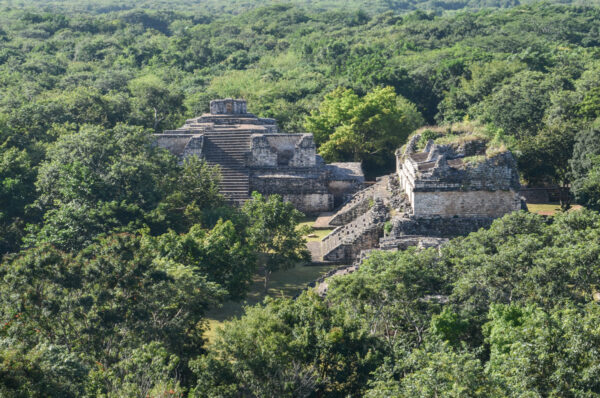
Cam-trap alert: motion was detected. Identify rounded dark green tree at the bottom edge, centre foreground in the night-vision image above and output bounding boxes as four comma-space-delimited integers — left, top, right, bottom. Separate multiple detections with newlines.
191, 292, 381, 397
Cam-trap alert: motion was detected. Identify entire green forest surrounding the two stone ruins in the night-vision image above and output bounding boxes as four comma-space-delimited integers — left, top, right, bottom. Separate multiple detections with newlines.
0, 0, 600, 397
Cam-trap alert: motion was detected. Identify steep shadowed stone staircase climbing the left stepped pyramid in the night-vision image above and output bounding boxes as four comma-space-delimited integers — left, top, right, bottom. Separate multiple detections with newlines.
203, 130, 253, 204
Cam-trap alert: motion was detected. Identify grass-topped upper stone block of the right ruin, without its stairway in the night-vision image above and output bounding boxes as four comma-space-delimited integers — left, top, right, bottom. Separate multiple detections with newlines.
397, 134, 521, 218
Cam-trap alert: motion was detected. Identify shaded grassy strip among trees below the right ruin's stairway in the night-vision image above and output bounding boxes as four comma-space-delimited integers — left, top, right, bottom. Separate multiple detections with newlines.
204, 265, 337, 340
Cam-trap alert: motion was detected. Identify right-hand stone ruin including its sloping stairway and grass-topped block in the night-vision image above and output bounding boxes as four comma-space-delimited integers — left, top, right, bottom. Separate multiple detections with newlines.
310, 128, 525, 264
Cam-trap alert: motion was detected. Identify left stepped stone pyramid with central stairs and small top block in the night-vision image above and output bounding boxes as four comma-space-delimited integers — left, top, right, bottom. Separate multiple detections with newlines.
156, 98, 364, 214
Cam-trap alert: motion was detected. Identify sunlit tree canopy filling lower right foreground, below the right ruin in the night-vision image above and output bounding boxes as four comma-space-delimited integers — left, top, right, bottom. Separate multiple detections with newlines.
195, 211, 600, 397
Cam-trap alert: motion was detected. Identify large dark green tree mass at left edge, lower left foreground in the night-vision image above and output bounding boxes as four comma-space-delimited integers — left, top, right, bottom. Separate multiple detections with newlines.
0, 234, 223, 372
